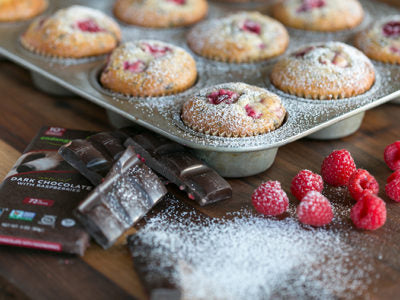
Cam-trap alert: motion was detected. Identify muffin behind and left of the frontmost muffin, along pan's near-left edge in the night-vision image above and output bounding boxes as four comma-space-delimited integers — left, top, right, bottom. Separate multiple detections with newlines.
100, 40, 197, 97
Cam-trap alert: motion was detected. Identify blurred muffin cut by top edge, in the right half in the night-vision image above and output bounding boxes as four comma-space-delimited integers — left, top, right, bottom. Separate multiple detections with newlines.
272, 0, 364, 31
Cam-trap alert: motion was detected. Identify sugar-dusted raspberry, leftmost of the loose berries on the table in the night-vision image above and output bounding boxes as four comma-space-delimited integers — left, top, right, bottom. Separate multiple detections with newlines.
251, 181, 289, 216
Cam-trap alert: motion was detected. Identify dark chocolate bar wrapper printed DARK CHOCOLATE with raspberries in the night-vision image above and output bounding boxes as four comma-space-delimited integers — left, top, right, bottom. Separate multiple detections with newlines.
0, 127, 93, 255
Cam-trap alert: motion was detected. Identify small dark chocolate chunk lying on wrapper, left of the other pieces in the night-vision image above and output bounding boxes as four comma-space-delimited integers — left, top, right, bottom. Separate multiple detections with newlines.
58, 139, 113, 185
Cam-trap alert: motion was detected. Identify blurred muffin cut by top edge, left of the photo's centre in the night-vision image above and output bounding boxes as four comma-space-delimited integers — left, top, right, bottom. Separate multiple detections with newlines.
114, 0, 208, 27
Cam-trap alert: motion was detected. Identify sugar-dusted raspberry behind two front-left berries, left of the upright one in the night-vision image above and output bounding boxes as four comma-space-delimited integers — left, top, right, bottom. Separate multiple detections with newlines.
290, 170, 324, 200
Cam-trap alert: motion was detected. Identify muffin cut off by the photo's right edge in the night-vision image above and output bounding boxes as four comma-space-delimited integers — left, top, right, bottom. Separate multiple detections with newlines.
355, 15, 400, 64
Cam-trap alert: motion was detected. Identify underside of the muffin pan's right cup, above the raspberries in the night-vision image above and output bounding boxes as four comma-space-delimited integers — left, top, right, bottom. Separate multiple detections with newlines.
308, 112, 365, 140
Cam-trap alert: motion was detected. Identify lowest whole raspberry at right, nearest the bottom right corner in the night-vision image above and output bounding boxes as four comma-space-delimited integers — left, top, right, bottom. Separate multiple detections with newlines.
350, 192, 386, 230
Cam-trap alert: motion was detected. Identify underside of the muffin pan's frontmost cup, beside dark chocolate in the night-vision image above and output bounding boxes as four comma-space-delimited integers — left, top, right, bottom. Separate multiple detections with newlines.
193, 148, 278, 178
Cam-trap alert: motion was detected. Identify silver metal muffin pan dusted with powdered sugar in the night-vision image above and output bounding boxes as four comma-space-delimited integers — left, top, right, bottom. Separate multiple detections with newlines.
0, 0, 400, 177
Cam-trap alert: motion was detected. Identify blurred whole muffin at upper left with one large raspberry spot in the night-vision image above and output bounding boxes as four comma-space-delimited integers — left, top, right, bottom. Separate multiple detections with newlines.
21, 5, 121, 58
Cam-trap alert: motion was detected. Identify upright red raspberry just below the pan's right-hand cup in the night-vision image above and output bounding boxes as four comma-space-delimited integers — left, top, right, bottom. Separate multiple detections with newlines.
321, 149, 356, 186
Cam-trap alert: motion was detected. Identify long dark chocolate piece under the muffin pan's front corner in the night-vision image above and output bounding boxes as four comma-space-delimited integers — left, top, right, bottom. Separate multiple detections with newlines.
124, 133, 232, 206
